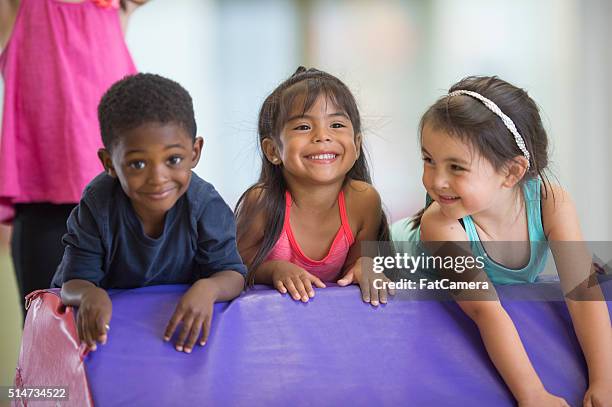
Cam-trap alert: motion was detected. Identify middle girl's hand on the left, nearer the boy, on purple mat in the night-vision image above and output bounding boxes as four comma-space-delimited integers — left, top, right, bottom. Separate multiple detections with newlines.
272, 262, 325, 302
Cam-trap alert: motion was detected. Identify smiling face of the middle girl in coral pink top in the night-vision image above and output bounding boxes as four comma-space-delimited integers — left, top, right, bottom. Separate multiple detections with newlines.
264, 95, 361, 184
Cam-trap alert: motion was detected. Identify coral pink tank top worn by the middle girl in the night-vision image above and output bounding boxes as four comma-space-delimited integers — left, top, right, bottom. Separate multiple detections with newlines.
266, 191, 355, 281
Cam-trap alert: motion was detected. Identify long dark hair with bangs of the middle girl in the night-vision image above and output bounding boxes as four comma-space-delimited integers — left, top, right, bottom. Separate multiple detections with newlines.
234, 66, 389, 285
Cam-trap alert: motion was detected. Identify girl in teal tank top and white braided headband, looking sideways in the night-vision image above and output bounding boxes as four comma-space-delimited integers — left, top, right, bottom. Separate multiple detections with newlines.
391, 77, 612, 406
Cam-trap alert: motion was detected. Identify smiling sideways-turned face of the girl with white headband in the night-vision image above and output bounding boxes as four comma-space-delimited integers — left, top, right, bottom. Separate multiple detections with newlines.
422, 125, 507, 219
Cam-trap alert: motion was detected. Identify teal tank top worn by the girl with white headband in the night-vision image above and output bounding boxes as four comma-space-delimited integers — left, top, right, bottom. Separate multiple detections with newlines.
391, 178, 549, 284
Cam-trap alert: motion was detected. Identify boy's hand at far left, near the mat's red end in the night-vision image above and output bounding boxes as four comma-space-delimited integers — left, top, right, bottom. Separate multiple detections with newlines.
77, 287, 113, 351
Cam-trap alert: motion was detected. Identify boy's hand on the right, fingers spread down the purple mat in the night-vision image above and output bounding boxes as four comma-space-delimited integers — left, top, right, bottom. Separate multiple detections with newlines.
164, 278, 215, 353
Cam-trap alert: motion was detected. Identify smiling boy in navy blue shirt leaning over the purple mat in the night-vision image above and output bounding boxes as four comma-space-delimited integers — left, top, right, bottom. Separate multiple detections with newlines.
53, 74, 246, 353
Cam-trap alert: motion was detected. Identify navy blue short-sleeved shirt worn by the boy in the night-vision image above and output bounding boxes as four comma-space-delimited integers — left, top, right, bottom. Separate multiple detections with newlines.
52, 173, 246, 289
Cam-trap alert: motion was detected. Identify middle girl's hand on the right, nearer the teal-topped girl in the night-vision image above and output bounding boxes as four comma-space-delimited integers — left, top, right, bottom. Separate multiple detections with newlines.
338, 257, 395, 307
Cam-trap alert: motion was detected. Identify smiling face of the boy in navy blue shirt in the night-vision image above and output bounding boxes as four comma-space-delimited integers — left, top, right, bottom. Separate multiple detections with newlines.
98, 123, 202, 224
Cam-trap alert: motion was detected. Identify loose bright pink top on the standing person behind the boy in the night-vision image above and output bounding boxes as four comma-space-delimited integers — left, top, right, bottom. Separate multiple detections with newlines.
0, 0, 136, 222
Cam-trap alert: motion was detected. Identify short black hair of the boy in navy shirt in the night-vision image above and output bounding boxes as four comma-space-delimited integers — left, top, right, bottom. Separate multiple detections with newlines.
98, 73, 197, 150
